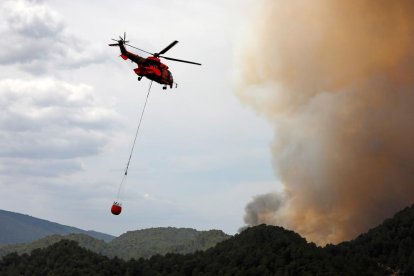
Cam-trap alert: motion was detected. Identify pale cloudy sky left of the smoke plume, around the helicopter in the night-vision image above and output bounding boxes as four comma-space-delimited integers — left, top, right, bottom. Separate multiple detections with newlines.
0, 0, 280, 235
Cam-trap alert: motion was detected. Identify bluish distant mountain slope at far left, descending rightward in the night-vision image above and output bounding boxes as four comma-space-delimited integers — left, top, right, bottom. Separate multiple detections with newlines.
0, 210, 114, 245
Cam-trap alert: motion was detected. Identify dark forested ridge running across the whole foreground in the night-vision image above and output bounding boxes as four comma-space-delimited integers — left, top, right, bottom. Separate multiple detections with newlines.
0, 206, 414, 276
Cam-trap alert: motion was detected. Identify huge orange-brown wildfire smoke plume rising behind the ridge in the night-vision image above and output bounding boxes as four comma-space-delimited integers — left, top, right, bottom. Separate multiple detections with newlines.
237, 0, 414, 244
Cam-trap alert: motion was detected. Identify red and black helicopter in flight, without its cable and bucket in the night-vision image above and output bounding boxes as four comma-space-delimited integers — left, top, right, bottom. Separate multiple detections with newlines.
109, 33, 201, 89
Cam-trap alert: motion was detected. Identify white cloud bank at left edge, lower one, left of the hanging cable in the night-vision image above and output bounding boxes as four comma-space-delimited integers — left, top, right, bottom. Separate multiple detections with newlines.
0, 78, 118, 175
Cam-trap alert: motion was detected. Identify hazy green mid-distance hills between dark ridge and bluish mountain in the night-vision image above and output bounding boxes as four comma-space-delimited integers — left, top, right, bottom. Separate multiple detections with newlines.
0, 227, 230, 260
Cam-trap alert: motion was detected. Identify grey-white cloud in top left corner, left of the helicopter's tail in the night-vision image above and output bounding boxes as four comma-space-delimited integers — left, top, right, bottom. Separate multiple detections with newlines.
0, 0, 105, 74
